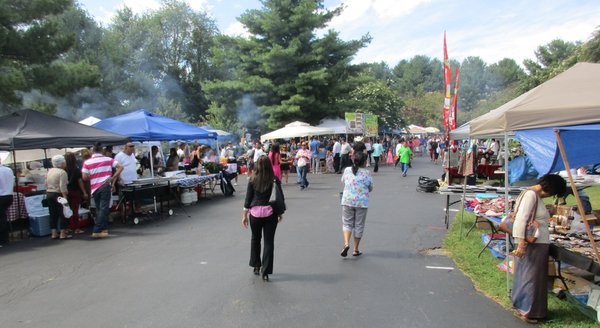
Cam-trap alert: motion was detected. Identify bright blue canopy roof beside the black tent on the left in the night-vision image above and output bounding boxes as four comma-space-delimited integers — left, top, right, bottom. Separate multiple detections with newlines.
93, 109, 217, 141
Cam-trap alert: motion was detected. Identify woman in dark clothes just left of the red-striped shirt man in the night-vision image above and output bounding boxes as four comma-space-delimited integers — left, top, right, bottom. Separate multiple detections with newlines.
65, 153, 88, 234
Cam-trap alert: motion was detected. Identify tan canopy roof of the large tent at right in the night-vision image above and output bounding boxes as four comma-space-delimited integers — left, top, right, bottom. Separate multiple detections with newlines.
470, 63, 600, 137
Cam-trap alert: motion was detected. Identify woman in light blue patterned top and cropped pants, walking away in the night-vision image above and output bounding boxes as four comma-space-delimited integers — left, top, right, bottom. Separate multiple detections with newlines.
340, 152, 373, 257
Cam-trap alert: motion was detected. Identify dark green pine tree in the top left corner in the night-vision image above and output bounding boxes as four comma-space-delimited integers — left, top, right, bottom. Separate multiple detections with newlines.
0, 0, 99, 112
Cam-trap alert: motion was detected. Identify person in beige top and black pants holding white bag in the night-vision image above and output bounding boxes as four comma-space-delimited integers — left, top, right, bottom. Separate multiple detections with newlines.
46, 155, 72, 240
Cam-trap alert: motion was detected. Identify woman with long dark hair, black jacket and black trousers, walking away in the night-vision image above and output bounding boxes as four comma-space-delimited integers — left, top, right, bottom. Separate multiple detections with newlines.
242, 156, 282, 281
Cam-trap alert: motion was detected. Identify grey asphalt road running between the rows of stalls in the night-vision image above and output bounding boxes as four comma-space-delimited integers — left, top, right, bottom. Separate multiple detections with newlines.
0, 157, 526, 328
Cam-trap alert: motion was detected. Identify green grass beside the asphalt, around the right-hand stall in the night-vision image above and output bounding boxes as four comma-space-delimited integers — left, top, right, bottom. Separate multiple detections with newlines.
444, 186, 600, 327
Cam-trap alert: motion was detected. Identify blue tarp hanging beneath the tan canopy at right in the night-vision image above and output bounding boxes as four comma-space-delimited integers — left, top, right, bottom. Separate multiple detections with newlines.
515, 124, 600, 176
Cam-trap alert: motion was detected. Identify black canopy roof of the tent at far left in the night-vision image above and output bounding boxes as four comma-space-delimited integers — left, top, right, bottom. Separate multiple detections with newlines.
0, 109, 128, 150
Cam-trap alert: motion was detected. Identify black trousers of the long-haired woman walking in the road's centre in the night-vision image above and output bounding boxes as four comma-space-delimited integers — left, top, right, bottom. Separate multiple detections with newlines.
250, 215, 277, 274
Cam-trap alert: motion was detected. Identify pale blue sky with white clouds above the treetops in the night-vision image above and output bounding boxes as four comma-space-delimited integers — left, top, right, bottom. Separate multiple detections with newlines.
77, 0, 600, 67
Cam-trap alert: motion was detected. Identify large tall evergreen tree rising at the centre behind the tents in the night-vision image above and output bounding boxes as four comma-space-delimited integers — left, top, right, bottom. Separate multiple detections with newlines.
207, 0, 370, 128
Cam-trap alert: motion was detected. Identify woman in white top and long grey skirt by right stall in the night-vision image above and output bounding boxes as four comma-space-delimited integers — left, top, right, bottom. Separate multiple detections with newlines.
512, 174, 566, 323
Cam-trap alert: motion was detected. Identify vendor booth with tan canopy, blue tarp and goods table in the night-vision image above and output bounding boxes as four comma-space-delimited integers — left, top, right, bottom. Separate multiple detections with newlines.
444, 63, 600, 320
